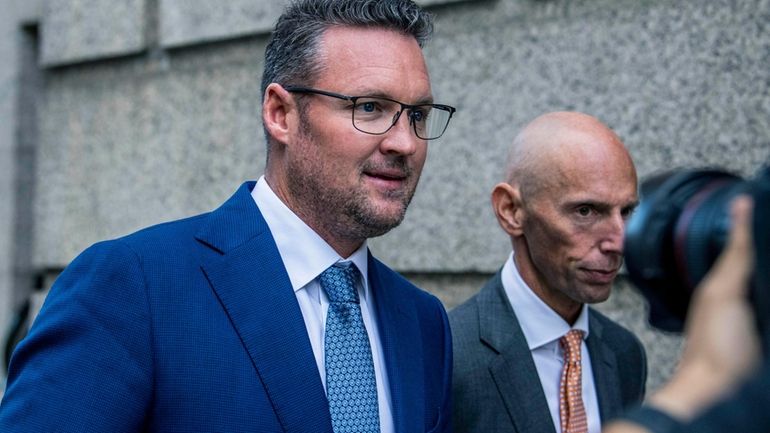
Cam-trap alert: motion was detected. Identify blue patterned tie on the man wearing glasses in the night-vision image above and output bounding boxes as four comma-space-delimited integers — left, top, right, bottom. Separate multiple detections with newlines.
320, 262, 380, 433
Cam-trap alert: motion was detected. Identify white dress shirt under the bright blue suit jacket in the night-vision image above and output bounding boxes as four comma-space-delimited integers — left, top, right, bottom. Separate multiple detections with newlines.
251, 176, 395, 433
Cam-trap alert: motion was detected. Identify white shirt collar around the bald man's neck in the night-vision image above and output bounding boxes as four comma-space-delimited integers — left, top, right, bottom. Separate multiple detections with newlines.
501, 253, 588, 350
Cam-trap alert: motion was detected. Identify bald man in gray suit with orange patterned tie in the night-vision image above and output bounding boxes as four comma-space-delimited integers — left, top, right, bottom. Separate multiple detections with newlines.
449, 112, 647, 433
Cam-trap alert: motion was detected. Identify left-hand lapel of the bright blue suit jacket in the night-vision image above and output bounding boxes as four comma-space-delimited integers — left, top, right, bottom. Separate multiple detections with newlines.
196, 183, 331, 432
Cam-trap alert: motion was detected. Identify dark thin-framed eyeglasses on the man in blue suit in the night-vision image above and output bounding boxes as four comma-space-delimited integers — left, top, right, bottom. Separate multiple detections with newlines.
284, 86, 457, 140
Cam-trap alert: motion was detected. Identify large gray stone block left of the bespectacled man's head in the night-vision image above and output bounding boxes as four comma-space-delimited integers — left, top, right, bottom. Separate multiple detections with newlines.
35, 39, 264, 267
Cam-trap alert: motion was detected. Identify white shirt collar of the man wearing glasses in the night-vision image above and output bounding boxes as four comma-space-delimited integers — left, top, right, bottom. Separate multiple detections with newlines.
251, 176, 369, 297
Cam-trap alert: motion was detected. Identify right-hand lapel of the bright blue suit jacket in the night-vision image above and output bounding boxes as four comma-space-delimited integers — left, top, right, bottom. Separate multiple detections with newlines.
369, 253, 425, 432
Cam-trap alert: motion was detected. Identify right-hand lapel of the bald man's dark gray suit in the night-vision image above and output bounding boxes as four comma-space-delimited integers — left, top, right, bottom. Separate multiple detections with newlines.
586, 309, 622, 420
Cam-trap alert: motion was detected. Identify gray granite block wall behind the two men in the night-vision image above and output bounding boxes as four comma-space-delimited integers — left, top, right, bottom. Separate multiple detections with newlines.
0, 0, 770, 394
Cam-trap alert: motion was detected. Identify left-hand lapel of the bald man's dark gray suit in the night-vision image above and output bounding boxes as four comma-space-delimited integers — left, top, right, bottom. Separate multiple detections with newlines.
477, 272, 556, 433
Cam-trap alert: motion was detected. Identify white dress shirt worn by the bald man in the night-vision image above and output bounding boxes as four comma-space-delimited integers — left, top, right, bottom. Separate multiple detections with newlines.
501, 253, 601, 433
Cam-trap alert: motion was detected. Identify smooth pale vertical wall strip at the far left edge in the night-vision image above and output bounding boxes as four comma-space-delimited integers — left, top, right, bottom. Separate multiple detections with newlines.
0, 0, 42, 386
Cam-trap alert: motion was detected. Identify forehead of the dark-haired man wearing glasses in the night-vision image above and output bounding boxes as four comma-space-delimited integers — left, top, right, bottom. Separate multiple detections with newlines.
314, 26, 431, 102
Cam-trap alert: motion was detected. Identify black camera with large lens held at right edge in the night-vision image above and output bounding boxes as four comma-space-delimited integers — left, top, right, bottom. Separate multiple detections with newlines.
624, 166, 770, 348
